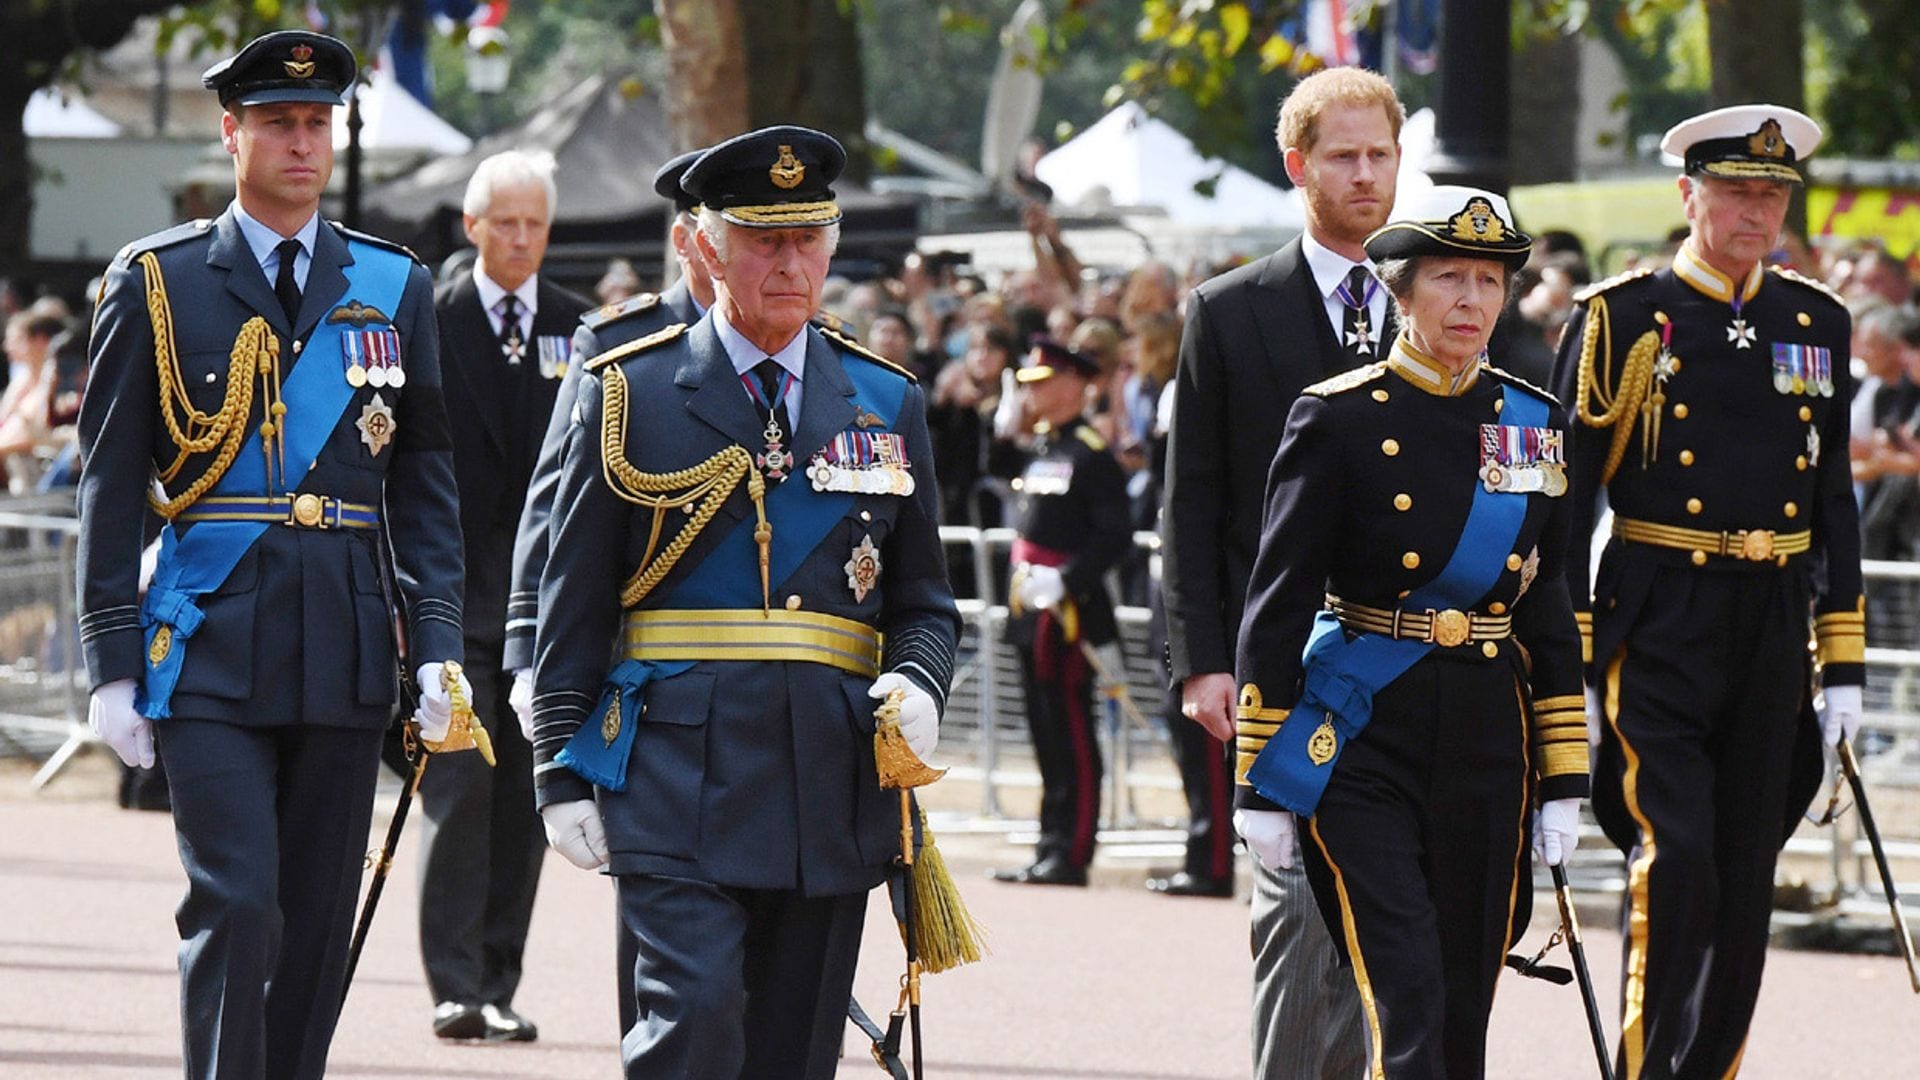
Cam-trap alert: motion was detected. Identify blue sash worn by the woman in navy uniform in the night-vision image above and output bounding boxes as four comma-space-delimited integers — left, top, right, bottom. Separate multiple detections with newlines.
1246, 386, 1548, 815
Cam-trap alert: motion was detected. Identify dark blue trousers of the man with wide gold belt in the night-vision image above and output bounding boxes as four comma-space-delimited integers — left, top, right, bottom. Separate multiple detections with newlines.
616, 874, 866, 1080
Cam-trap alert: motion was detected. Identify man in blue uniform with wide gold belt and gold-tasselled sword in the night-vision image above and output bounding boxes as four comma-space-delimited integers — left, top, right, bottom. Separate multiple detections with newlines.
534, 127, 958, 1080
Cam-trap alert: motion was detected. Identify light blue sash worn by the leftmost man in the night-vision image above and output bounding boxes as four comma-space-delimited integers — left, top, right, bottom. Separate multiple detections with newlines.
134, 240, 413, 721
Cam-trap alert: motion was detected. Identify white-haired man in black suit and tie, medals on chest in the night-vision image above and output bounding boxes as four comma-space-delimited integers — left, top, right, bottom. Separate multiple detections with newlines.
420, 150, 588, 1042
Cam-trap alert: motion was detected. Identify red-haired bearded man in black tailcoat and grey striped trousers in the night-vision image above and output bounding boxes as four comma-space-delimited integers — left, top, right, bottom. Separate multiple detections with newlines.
1160, 67, 1405, 1078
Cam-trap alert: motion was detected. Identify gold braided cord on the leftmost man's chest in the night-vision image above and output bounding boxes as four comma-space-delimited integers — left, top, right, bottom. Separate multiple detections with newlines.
140, 252, 286, 521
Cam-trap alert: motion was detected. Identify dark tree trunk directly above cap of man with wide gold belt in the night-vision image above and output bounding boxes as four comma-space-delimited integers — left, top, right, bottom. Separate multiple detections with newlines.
745, 0, 870, 181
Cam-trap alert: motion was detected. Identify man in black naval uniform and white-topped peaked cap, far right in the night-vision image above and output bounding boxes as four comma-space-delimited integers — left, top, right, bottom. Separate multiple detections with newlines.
1555, 106, 1866, 1080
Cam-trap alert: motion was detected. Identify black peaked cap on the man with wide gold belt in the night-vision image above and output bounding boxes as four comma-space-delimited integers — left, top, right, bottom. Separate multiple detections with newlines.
680, 125, 847, 229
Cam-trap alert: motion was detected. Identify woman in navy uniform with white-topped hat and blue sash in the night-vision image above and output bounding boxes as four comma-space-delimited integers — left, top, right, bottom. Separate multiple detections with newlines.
1238, 186, 1586, 1080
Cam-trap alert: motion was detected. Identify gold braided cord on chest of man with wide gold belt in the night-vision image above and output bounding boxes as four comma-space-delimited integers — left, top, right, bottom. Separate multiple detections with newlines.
601, 363, 774, 609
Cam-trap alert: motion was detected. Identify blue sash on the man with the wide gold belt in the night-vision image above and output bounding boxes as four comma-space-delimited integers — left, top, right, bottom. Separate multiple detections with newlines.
555, 353, 906, 780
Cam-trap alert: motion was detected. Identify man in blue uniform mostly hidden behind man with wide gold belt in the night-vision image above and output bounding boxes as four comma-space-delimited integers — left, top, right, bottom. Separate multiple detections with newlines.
503, 150, 714, 1032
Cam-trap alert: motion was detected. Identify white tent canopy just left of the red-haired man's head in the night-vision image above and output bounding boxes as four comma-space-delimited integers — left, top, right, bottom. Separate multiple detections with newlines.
1033, 102, 1306, 229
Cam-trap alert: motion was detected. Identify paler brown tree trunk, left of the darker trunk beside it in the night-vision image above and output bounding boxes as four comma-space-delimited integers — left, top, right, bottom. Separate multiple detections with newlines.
655, 0, 755, 150
